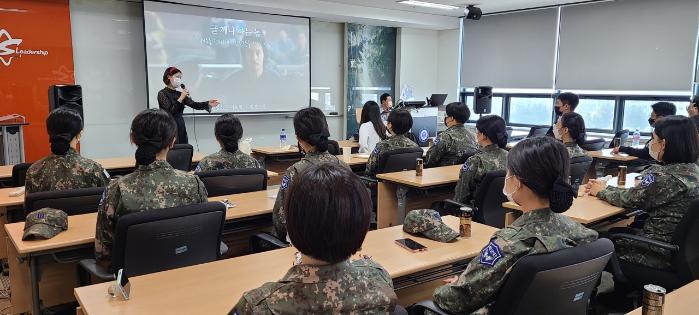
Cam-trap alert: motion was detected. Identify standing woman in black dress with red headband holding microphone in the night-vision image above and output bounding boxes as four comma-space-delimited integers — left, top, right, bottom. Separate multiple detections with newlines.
158, 67, 219, 143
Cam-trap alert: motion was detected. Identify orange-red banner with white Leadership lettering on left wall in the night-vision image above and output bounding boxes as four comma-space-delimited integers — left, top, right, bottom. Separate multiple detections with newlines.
0, 0, 75, 161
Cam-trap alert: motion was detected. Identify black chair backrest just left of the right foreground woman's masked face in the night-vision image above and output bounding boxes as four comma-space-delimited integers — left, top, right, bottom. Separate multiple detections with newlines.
473, 170, 507, 228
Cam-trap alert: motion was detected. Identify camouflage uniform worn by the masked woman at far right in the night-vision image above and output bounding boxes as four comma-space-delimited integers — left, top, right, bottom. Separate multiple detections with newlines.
597, 163, 699, 268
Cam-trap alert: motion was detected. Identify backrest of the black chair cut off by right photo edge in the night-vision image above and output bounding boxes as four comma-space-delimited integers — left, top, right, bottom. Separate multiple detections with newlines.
671, 199, 699, 283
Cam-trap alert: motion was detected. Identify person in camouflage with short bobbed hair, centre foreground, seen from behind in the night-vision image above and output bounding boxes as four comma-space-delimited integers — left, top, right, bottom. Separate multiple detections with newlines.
231, 162, 397, 314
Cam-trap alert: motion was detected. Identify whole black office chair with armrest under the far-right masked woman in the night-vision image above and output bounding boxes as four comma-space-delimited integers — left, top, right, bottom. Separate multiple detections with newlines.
611, 199, 699, 292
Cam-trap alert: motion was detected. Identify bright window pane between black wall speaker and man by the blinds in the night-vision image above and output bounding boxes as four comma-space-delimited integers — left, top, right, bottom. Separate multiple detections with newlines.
509, 97, 553, 126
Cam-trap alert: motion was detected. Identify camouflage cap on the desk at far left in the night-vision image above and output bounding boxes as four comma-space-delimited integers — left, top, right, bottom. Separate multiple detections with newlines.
22, 208, 68, 241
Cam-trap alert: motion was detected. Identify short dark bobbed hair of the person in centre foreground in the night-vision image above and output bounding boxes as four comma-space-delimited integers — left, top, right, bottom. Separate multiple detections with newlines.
284, 163, 372, 264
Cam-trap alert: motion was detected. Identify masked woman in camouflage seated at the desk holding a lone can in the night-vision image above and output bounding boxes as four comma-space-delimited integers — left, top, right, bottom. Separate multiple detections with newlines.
454, 115, 507, 204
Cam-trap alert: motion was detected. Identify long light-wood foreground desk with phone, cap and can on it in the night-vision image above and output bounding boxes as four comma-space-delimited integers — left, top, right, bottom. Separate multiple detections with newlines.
75, 217, 496, 315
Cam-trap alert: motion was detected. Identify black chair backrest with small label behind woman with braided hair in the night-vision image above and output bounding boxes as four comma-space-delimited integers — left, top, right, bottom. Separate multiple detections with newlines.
110, 202, 226, 277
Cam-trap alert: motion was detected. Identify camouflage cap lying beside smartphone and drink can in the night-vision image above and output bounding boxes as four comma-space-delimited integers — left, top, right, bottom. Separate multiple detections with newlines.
403, 209, 459, 243
